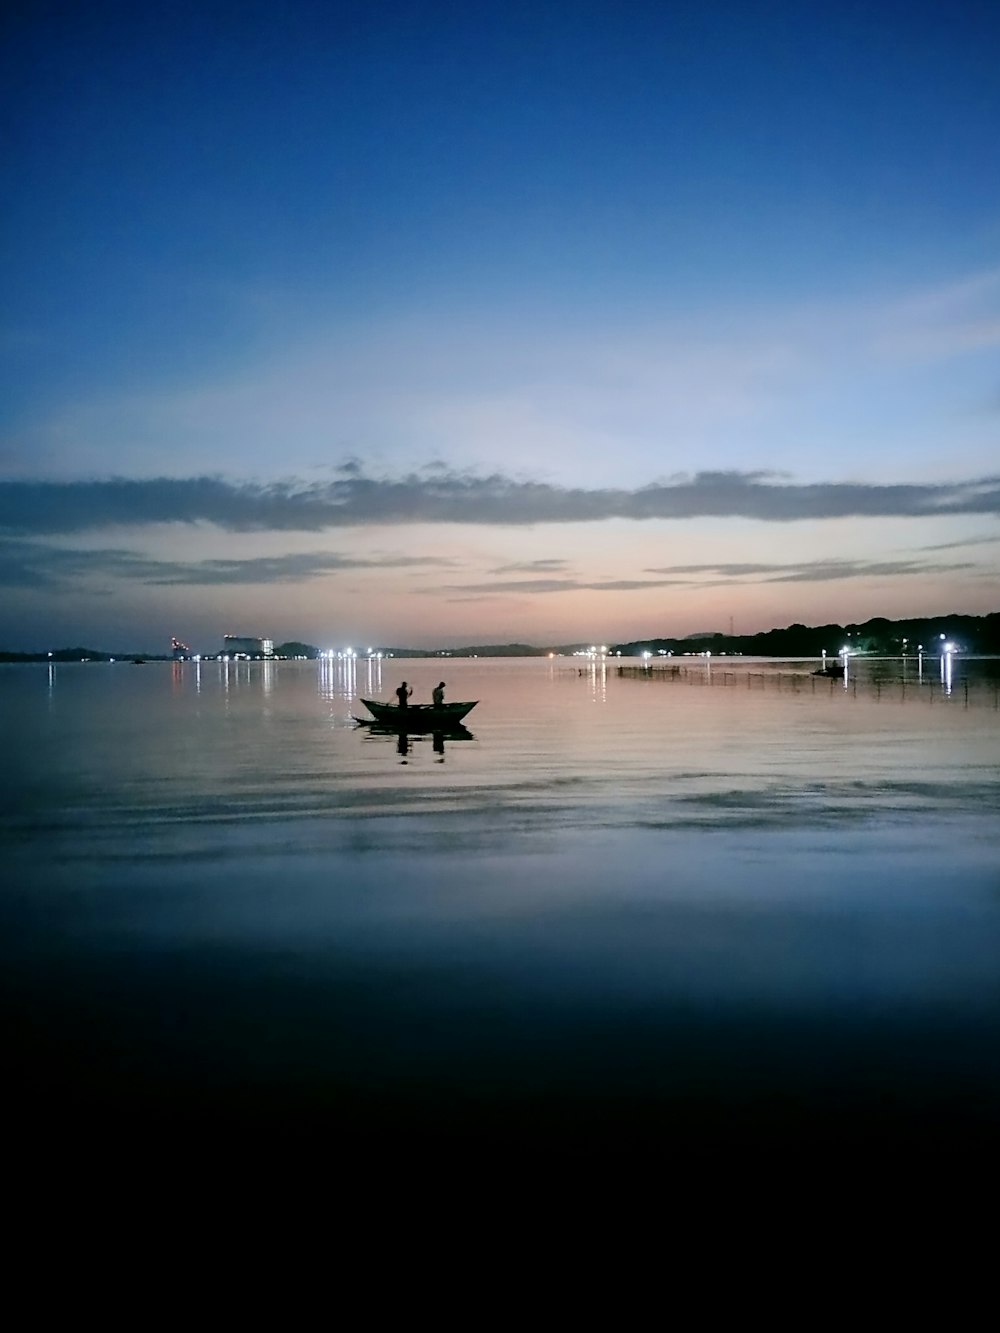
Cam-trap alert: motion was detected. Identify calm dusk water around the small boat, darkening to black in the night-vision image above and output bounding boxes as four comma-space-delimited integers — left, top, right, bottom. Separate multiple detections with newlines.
0, 659, 1000, 1156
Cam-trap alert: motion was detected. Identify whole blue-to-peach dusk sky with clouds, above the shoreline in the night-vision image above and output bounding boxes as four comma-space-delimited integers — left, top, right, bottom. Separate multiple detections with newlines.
0, 0, 1000, 652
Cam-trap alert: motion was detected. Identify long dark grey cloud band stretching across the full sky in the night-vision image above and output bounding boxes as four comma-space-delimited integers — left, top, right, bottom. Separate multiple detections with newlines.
0, 465, 1000, 535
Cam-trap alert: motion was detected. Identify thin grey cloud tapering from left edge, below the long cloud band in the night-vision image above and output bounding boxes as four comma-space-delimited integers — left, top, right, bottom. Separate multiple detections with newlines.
0, 539, 455, 588
